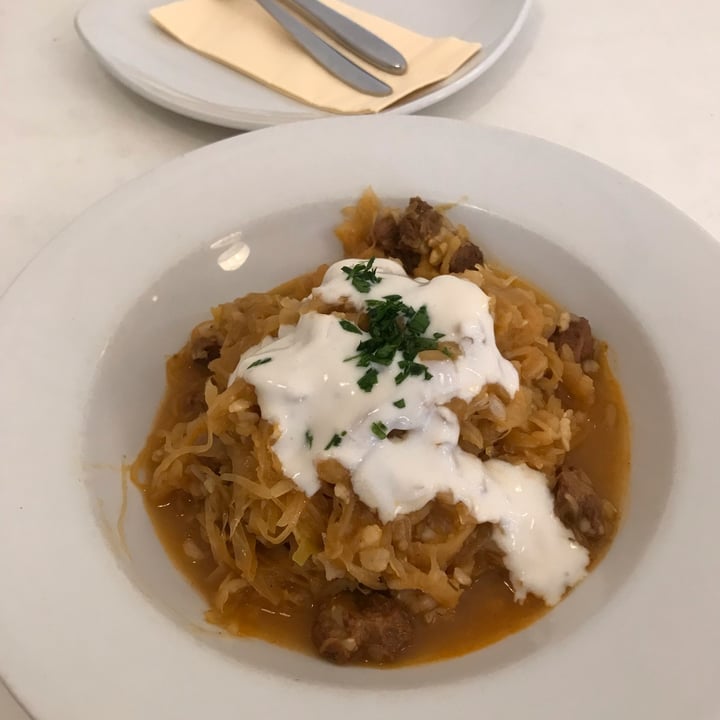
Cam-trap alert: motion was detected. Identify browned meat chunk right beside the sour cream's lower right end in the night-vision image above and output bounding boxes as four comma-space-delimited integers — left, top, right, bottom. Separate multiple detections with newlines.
555, 465, 612, 542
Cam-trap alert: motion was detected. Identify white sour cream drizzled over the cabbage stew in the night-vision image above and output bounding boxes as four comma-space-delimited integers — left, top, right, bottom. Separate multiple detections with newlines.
229, 259, 589, 605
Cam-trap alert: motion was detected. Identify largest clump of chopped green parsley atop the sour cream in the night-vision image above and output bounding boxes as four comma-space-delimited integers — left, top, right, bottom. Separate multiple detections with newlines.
347, 296, 443, 392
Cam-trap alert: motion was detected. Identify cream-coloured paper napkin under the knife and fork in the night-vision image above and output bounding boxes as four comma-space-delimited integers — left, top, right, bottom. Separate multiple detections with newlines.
150, 0, 480, 113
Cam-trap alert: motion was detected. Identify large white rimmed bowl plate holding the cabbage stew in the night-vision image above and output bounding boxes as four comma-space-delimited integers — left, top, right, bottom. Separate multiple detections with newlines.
0, 116, 720, 720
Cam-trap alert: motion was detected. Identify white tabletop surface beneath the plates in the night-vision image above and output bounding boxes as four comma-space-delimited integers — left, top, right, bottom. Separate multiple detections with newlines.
0, 0, 720, 720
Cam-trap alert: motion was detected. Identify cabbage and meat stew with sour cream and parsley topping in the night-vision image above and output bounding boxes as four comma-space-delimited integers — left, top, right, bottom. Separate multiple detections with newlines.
132, 191, 630, 665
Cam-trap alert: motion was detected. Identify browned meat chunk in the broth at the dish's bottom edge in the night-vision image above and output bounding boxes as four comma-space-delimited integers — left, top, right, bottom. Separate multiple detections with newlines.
312, 592, 413, 665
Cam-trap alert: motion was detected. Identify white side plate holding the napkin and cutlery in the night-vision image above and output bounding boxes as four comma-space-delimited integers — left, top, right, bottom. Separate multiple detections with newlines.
76, 0, 530, 130
